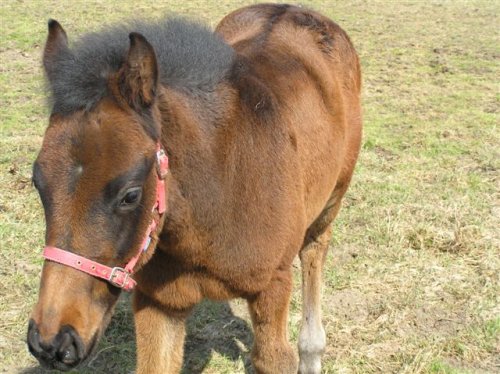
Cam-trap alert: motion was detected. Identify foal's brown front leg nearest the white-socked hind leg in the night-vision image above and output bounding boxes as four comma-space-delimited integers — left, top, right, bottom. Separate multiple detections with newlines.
248, 269, 297, 374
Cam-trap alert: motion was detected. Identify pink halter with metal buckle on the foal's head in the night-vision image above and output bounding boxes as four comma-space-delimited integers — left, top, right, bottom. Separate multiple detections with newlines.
43, 142, 168, 291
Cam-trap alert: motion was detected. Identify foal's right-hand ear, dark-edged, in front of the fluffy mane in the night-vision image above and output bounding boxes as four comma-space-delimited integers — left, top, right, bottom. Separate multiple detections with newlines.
120, 32, 158, 112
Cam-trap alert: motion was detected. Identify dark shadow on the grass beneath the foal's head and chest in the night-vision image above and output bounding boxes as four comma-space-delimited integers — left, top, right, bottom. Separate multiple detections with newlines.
18, 295, 254, 374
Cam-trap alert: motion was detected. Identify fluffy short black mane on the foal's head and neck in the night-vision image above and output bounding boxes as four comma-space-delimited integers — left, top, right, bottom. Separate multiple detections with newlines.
49, 18, 234, 114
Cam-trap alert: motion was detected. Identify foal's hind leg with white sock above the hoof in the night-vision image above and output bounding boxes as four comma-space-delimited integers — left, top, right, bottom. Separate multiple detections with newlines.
298, 198, 340, 374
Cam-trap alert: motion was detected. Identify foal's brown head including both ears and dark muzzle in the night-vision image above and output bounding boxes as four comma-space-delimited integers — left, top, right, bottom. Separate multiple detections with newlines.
28, 20, 165, 370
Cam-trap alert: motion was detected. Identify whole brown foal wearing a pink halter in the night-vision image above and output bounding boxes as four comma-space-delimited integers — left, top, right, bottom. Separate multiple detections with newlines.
28, 4, 361, 374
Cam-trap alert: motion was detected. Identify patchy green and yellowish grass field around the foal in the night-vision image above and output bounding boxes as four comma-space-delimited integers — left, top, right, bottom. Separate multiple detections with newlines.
0, 0, 500, 374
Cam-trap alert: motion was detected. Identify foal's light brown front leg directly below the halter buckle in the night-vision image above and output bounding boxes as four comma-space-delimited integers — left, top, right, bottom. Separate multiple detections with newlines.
134, 291, 188, 374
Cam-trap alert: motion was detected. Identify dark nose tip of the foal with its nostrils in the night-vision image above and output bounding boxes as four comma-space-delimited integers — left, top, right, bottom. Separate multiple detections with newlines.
27, 320, 88, 370
